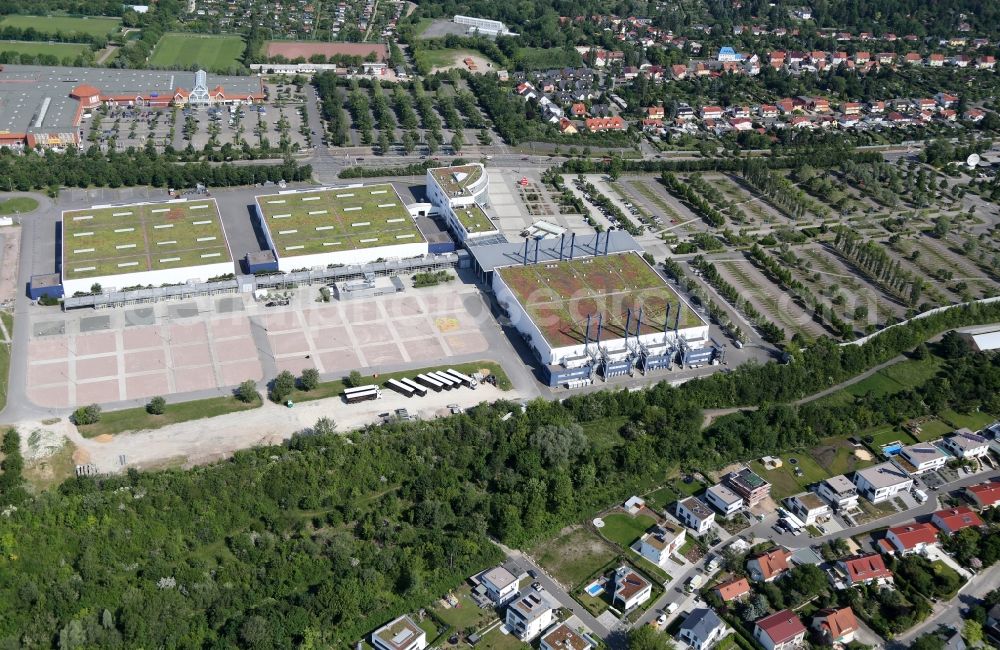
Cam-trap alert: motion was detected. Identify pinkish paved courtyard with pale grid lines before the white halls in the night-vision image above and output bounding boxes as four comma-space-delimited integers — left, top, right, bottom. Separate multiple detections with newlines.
23, 282, 491, 408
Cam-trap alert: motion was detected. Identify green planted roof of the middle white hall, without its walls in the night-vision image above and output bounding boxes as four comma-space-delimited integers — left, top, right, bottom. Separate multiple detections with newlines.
257, 183, 427, 258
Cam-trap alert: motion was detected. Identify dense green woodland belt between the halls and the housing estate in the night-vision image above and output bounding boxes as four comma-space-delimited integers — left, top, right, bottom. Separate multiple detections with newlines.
0, 298, 1000, 648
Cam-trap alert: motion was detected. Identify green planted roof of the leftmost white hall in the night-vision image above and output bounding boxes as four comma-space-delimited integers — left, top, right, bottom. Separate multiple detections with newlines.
62, 199, 232, 280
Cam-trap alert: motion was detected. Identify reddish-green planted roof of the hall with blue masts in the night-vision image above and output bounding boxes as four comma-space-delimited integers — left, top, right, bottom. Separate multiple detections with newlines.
496, 252, 705, 348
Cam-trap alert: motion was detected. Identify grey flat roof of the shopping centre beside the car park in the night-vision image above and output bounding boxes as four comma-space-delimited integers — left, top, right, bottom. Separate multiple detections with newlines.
0, 64, 261, 133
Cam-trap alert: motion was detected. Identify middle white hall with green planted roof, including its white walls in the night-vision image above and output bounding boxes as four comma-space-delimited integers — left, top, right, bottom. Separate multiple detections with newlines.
255, 183, 428, 272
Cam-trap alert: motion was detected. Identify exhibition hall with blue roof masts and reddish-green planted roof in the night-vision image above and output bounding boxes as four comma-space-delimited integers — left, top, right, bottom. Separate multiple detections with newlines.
491, 242, 716, 385
